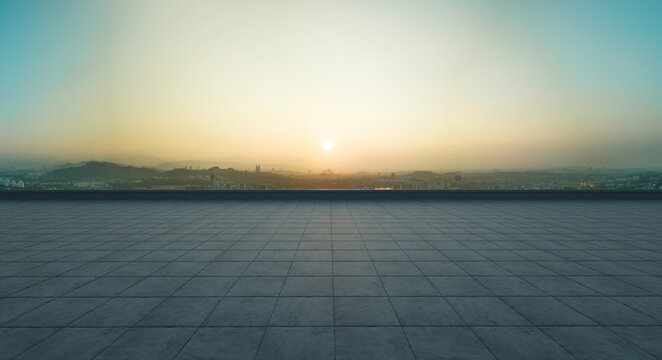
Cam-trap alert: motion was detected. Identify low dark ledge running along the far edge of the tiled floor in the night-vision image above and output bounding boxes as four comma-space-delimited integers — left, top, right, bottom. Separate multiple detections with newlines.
0, 190, 662, 201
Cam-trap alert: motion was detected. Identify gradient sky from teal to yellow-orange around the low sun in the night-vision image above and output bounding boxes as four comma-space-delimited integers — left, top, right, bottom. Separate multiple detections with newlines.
0, 0, 662, 171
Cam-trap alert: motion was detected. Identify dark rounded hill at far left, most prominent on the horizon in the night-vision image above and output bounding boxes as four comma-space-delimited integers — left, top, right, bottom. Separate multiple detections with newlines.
43, 161, 161, 179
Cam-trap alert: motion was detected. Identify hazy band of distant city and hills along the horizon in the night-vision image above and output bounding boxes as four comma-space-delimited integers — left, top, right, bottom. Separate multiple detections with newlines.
0, 161, 662, 190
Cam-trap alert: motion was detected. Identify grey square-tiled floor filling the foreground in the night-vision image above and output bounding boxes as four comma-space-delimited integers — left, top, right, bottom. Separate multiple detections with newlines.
0, 201, 662, 360
